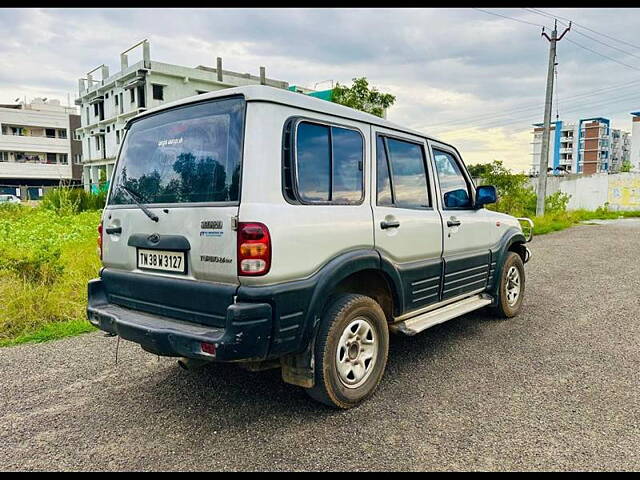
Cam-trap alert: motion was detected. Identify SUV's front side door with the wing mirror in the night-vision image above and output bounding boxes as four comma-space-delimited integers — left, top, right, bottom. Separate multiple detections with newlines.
430, 142, 496, 300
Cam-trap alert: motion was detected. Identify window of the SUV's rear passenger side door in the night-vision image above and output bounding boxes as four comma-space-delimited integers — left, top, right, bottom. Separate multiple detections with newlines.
376, 136, 431, 208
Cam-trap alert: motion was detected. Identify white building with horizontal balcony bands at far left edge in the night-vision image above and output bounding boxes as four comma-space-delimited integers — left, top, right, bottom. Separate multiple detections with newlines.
0, 98, 81, 199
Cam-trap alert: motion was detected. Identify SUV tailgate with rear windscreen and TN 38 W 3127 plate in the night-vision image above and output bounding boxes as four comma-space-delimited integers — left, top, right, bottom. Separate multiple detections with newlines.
103, 97, 245, 324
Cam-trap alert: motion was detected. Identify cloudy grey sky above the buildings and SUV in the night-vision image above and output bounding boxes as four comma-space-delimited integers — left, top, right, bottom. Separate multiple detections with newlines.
0, 8, 640, 171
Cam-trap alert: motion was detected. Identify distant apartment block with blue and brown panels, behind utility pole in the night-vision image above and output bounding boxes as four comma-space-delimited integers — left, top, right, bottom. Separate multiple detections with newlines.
530, 117, 631, 175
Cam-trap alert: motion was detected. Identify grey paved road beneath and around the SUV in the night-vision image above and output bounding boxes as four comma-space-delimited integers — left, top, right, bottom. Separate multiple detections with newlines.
0, 221, 640, 470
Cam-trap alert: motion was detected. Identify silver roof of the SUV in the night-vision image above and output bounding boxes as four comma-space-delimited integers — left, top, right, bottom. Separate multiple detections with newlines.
129, 85, 449, 145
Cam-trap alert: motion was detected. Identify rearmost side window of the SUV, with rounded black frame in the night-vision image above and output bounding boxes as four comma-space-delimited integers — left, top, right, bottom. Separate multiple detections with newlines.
284, 121, 364, 205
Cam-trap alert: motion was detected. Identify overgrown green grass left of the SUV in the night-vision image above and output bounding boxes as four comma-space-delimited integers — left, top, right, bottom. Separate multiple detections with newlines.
0, 206, 100, 346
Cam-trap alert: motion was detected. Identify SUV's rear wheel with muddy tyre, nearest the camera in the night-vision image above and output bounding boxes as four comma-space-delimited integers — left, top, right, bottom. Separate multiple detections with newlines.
306, 294, 389, 409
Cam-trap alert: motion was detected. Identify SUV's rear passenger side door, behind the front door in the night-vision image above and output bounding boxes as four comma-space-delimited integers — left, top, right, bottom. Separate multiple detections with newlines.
372, 128, 442, 313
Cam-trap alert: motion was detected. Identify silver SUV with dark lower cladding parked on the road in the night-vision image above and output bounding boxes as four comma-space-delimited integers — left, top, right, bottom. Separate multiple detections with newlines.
87, 86, 531, 408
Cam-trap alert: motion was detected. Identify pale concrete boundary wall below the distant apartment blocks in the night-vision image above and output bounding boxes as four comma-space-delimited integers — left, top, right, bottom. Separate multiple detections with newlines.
530, 173, 640, 210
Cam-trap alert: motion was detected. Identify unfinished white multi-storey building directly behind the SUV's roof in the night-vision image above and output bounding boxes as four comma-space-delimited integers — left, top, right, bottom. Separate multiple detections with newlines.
75, 40, 289, 189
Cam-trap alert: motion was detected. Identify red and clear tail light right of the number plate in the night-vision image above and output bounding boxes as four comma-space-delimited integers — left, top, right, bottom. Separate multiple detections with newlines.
238, 222, 271, 276
